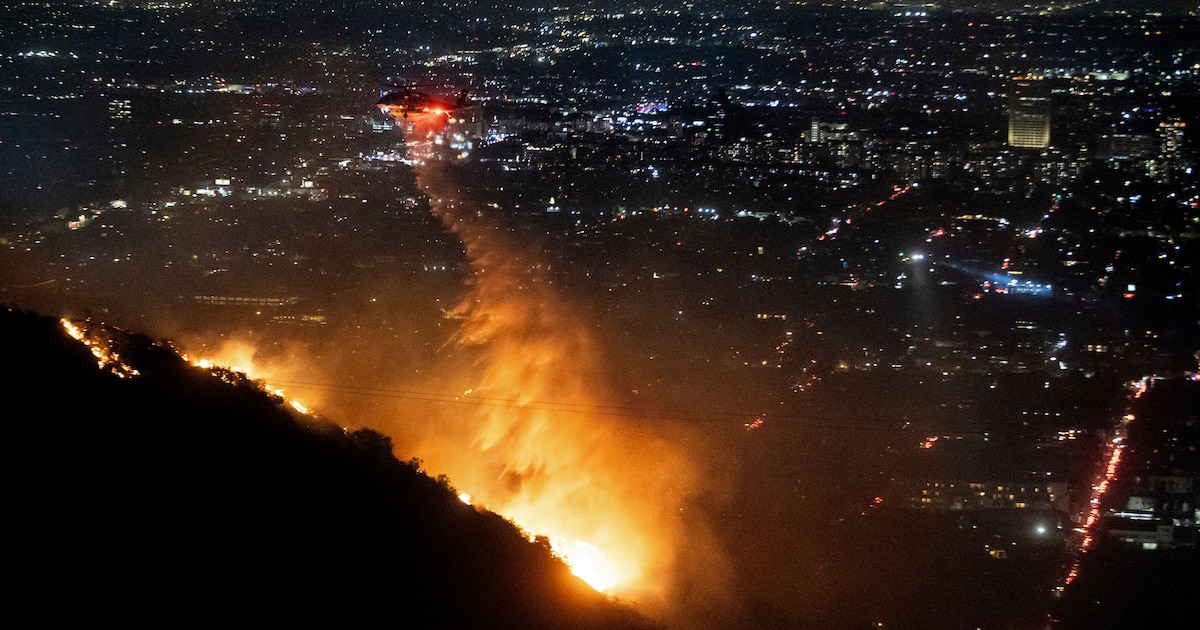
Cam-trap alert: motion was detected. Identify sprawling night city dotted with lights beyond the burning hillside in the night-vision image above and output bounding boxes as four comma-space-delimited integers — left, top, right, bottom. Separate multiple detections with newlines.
0, 0, 1200, 628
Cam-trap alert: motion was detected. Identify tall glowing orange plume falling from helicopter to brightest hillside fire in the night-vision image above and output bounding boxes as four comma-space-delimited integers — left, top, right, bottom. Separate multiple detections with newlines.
385, 120, 724, 614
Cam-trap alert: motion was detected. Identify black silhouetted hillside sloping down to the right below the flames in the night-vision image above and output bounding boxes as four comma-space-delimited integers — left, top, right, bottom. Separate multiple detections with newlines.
0, 310, 653, 629
